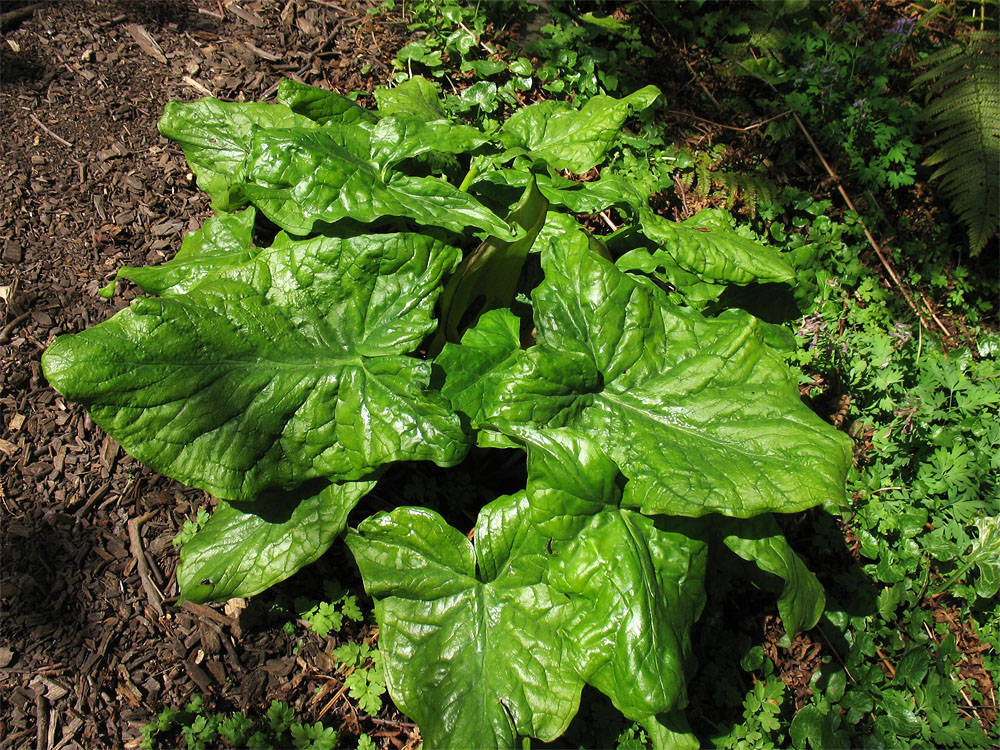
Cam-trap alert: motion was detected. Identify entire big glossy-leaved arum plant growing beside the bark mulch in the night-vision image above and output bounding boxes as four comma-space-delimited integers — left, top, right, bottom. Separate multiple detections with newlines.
43, 78, 850, 748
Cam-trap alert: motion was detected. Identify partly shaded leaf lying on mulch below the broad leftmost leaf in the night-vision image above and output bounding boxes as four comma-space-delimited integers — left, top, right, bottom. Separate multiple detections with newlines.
177, 482, 375, 602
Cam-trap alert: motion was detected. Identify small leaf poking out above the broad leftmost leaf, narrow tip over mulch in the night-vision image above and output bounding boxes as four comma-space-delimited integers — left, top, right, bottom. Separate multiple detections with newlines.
101, 208, 258, 297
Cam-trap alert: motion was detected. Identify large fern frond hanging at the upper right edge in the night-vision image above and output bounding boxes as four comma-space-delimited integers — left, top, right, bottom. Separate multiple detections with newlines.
914, 32, 1000, 255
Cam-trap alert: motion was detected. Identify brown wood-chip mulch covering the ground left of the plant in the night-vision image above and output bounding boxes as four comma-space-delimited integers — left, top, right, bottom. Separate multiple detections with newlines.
0, 0, 416, 748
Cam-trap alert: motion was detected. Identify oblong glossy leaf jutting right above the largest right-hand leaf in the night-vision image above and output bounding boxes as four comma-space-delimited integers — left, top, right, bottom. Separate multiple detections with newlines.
639, 209, 795, 284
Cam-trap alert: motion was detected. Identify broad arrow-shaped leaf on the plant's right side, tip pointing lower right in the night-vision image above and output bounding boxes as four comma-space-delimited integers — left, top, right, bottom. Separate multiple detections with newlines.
486, 234, 851, 517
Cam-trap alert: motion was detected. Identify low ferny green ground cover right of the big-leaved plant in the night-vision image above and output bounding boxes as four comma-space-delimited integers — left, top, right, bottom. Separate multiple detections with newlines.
362, 2, 1000, 747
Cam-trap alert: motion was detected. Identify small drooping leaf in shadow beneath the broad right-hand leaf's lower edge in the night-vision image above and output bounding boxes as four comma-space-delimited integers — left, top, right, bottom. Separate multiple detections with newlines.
718, 515, 826, 648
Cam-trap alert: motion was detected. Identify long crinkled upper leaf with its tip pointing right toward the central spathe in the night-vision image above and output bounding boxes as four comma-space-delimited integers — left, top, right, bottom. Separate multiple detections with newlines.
243, 126, 514, 239
